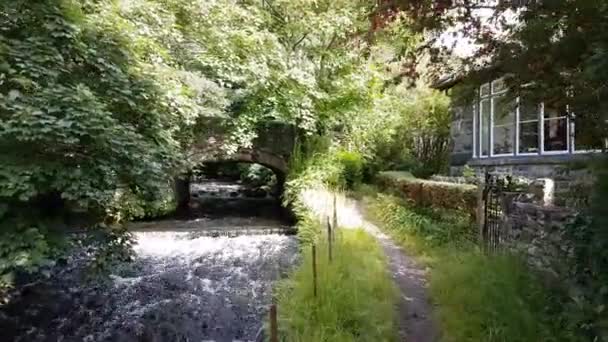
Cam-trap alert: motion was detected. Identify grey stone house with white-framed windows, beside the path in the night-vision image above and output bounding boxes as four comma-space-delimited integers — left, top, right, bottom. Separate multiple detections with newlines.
435, 78, 607, 204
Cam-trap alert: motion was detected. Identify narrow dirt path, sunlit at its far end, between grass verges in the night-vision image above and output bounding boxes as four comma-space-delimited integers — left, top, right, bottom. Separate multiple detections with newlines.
303, 190, 440, 342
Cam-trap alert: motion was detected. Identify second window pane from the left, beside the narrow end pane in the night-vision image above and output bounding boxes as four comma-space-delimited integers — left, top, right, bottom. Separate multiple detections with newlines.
492, 96, 515, 154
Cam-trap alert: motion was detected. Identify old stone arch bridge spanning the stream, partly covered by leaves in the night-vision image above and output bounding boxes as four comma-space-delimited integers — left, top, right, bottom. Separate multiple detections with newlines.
175, 118, 296, 208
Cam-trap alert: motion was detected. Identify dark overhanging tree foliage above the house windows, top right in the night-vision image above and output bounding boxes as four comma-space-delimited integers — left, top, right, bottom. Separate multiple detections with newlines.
376, 0, 608, 139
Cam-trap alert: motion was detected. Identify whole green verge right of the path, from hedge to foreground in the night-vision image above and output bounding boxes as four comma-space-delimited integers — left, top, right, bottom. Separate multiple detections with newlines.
362, 189, 576, 342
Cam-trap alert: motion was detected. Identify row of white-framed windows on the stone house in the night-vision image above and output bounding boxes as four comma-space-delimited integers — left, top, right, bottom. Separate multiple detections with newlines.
473, 80, 608, 158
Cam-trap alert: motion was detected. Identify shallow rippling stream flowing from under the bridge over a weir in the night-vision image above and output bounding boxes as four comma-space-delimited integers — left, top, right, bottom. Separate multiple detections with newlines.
0, 180, 298, 341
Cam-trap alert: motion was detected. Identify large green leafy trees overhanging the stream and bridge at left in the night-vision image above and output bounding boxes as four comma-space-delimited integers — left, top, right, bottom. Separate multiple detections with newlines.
0, 0, 390, 288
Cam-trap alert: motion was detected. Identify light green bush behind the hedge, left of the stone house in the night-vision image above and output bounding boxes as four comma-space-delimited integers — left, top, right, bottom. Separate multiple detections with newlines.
344, 84, 451, 177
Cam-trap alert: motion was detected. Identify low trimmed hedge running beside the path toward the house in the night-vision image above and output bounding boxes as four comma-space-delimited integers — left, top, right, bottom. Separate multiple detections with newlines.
376, 171, 477, 221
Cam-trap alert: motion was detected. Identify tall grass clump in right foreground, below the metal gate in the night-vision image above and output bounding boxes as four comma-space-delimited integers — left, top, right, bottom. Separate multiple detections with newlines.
431, 251, 569, 342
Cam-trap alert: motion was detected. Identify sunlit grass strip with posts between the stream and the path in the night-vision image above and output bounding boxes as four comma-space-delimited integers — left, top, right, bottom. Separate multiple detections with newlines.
277, 221, 397, 342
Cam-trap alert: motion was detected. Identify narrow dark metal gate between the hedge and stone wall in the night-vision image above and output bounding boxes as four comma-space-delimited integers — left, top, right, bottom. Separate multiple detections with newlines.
481, 172, 508, 251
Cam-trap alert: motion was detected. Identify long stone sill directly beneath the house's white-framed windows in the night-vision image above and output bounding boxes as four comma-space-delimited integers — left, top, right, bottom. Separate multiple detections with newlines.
468, 153, 596, 166
